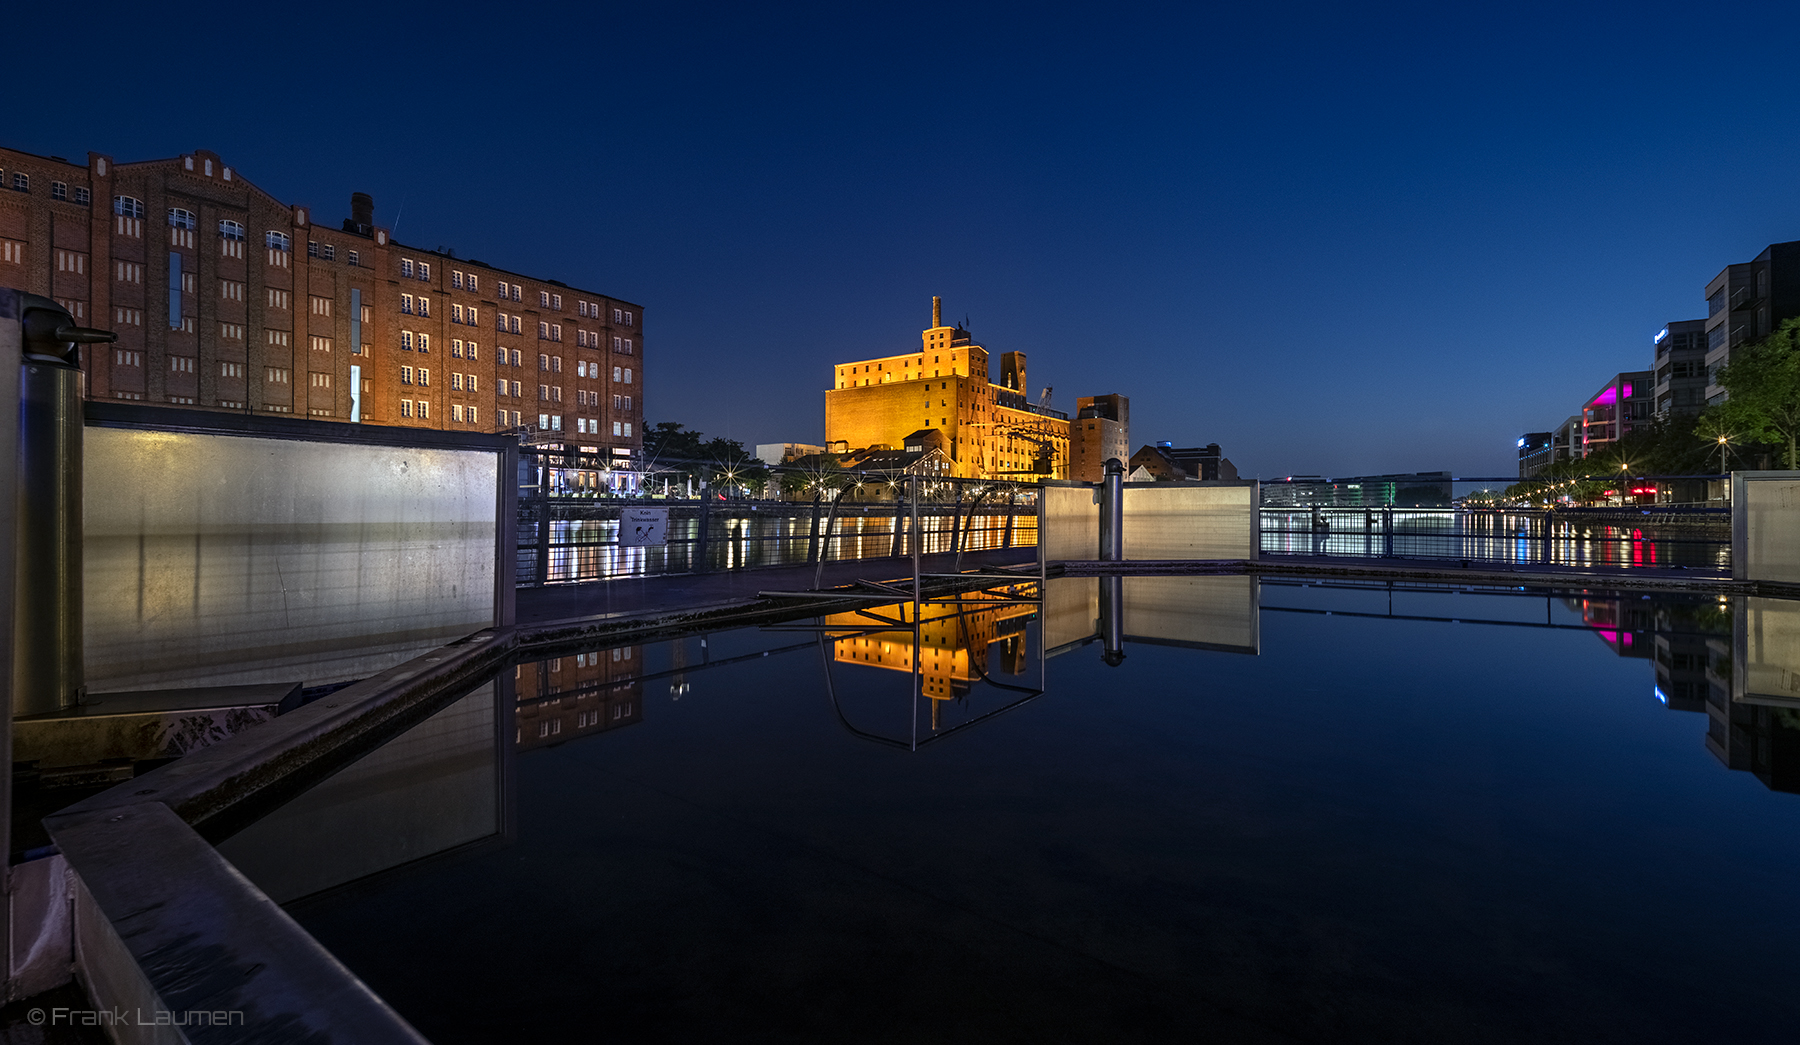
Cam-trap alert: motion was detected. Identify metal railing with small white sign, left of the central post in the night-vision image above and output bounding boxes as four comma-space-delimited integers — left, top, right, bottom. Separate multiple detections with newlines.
517, 471, 1037, 585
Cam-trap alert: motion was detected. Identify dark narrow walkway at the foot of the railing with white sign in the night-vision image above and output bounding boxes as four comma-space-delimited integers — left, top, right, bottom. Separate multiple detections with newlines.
518, 547, 1037, 624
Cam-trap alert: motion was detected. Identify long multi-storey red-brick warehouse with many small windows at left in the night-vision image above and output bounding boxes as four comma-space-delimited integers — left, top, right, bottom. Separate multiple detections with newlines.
0, 141, 644, 468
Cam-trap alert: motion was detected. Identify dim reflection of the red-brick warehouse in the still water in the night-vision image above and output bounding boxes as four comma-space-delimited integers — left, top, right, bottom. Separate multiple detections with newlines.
513, 646, 644, 750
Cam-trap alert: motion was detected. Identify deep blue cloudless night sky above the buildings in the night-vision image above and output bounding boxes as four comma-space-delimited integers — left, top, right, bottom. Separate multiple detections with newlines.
14, 4, 1800, 477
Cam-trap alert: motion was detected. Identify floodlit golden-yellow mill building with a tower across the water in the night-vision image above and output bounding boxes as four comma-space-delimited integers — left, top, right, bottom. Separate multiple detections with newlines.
824, 299, 1071, 478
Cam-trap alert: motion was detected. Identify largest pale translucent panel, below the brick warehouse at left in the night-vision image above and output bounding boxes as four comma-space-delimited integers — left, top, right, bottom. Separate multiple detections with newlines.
83, 415, 511, 691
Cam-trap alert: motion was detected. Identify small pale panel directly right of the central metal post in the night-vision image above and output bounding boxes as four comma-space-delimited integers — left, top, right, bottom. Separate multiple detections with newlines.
1125, 482, 1260, 561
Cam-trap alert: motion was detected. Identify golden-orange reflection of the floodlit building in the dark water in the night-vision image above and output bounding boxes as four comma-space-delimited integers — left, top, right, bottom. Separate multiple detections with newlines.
824, 592, 1037, 728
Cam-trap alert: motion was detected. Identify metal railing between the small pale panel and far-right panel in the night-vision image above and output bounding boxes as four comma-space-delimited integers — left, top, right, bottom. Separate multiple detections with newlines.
1262, 507, 1732, 572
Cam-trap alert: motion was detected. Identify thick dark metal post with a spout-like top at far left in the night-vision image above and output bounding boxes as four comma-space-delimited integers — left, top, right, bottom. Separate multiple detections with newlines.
13, 295, 119, 718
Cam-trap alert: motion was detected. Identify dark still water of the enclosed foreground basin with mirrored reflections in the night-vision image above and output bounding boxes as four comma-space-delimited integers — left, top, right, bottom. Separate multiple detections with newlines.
227, 577, 1800, 1043
